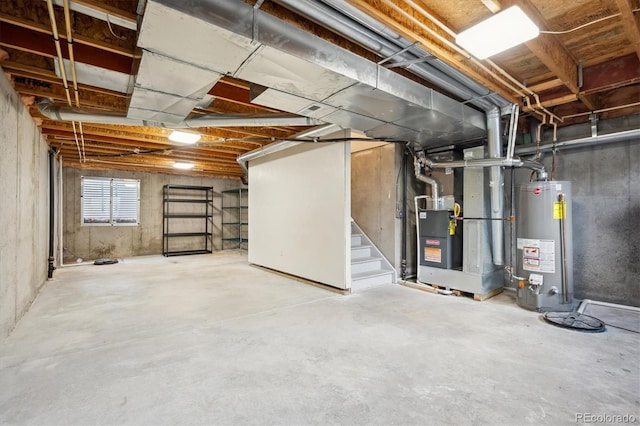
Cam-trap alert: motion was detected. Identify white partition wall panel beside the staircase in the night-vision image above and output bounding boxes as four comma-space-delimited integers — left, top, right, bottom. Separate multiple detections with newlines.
249, 139, 351, 289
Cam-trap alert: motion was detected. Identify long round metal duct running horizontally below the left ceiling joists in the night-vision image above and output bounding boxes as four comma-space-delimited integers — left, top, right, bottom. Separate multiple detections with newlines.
36, 98, 324, 129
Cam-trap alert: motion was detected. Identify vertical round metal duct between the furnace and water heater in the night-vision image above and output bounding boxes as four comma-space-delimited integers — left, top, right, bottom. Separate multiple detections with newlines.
487, 108, 504, 265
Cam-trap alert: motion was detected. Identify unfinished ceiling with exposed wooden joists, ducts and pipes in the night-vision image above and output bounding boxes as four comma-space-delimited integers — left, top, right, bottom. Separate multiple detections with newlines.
0, 0, 640, 178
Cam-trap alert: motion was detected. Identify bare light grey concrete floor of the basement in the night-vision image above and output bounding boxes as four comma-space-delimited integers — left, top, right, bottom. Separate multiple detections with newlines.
0, 252, 640, 425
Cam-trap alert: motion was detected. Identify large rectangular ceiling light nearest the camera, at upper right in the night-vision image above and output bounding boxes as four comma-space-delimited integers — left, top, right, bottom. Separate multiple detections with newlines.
456, 6, 540, 59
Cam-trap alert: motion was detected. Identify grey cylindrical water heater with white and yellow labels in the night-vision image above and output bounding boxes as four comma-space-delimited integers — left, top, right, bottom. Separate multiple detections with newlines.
514, 181, 573, 312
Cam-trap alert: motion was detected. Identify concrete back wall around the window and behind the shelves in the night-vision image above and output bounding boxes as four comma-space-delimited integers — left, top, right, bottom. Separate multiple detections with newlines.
63, 167, 242, 263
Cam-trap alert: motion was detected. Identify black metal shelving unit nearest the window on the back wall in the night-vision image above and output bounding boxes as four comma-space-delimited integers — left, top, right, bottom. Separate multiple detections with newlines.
162, 185, 213, 257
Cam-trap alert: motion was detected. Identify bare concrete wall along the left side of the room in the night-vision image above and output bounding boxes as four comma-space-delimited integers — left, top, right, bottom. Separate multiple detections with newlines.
0, 69, 49, 341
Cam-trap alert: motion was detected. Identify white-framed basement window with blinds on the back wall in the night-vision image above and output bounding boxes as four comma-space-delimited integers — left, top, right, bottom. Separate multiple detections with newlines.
81, 176, 140, 226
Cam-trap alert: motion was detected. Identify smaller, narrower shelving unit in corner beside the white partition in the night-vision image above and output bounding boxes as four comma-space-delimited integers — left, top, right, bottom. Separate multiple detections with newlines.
222, 188, 249, 249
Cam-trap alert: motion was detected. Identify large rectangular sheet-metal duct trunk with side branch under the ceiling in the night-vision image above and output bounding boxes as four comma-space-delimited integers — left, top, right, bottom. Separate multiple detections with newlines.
138, 0, 486, 147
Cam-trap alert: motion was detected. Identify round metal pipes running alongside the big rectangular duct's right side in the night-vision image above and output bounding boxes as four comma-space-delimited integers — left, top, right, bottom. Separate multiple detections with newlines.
274, 0, 509, 110
